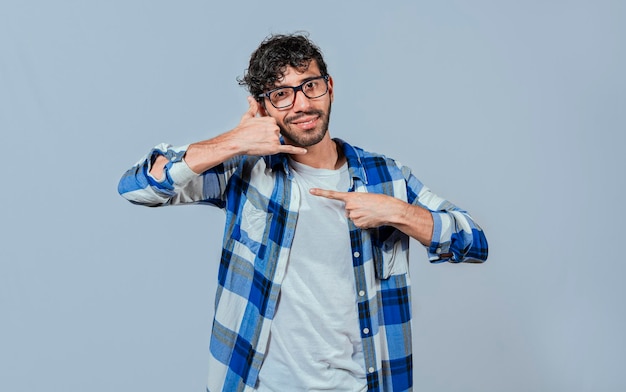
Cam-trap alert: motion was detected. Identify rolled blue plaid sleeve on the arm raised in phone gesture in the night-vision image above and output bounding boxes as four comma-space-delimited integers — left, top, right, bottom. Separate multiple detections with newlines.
118, 143, 234, 207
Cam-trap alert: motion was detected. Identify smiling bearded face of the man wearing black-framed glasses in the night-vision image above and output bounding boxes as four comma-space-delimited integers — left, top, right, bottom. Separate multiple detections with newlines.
262, 60, 333, 147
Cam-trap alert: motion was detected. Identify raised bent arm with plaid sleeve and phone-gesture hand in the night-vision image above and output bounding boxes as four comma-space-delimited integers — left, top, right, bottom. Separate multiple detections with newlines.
118, 97, 306, 206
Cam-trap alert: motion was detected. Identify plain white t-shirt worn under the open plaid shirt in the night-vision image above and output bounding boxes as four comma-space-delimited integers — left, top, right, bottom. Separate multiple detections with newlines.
257, 160, 367, 392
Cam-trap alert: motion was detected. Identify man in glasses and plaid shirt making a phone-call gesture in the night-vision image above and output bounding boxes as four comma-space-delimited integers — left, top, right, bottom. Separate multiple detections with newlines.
119, 35, 487, 391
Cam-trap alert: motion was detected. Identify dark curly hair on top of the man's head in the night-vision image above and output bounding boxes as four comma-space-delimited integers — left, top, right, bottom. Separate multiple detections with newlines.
237, 33, 328, 100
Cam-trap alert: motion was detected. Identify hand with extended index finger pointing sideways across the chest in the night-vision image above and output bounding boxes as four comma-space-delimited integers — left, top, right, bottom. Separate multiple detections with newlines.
309, 188, 400, 229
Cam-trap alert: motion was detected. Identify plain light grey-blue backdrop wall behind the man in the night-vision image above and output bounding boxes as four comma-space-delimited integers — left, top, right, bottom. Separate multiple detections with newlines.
0, 0, 626, 392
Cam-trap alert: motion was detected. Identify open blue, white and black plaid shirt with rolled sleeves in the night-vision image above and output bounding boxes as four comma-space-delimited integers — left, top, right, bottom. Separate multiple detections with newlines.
119, 139, 487, 391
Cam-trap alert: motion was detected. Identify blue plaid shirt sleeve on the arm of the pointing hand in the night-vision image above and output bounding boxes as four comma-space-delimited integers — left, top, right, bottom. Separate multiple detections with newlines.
402, 167, 488, 263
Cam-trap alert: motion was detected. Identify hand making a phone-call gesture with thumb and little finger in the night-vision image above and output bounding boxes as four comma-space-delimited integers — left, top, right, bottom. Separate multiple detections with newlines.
228, 96, 307, 155
